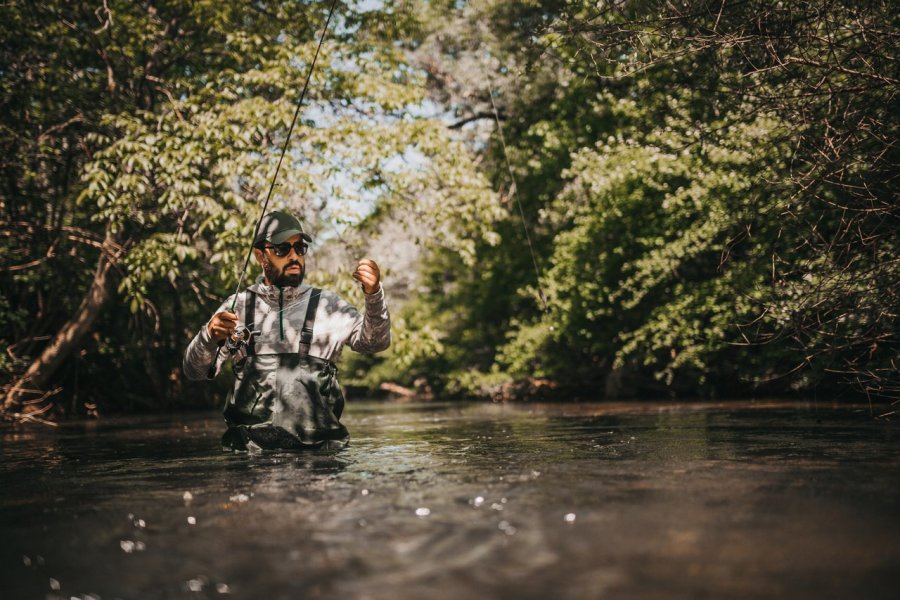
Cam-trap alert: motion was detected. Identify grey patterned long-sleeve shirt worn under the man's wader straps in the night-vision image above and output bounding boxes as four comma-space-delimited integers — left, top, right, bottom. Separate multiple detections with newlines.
183, 281, 391, 380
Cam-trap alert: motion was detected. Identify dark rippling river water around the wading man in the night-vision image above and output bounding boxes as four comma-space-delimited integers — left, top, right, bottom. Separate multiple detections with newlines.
0, 402, 900, 600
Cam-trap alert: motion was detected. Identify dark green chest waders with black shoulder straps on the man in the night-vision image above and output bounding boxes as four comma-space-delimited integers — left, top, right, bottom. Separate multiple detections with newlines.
222, 288, 350, 450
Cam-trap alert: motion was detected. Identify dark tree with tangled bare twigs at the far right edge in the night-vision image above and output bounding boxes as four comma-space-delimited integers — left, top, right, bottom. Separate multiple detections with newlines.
550, 0, 900, 398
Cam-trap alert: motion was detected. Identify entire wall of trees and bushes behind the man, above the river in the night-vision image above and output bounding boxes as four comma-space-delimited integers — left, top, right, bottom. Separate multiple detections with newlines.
0, 0, 900, 422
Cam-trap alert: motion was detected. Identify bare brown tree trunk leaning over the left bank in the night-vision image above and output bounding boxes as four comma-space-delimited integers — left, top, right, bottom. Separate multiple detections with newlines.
0, 236, 121, 413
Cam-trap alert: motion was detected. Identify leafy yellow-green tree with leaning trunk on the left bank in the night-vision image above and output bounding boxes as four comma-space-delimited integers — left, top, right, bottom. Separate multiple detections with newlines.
3, 2, 500, 414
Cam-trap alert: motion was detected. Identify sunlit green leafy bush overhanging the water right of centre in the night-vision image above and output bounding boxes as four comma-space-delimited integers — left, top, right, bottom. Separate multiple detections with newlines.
500, 104, 778, 385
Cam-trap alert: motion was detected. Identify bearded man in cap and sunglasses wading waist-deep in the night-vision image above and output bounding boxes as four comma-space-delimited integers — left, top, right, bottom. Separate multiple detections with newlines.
184, 211, 391, 450
